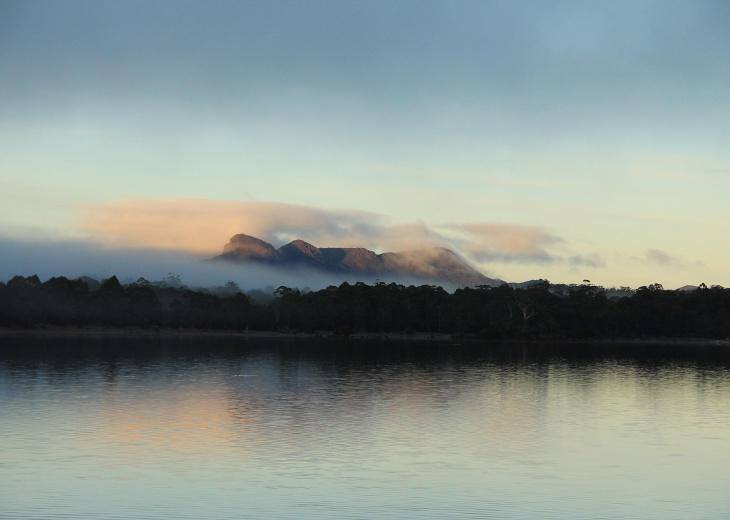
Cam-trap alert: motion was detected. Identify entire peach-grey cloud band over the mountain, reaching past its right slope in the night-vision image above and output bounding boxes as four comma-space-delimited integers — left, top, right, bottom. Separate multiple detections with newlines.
79, 199, 580, 267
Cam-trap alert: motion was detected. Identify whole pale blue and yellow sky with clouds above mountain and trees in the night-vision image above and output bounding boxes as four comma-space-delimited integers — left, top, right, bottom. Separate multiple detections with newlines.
0, 0, 730, 289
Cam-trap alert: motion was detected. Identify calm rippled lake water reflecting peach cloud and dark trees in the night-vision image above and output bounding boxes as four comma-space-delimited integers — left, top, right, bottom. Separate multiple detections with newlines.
0, 336, 730, 520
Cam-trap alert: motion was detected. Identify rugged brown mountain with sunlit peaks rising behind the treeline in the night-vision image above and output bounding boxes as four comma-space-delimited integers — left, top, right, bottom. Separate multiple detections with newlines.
212, 234, 500, 287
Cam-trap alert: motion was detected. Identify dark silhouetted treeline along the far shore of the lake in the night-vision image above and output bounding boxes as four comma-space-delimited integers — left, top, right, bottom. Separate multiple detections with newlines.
0, 276, 730, 339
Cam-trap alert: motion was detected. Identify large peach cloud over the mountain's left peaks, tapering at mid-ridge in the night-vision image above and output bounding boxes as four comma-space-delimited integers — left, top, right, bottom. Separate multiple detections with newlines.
79, 199, 382, 255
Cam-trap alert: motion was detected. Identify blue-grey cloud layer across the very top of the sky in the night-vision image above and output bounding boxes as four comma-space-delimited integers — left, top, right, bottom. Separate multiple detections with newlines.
0, 0, 730, 150
